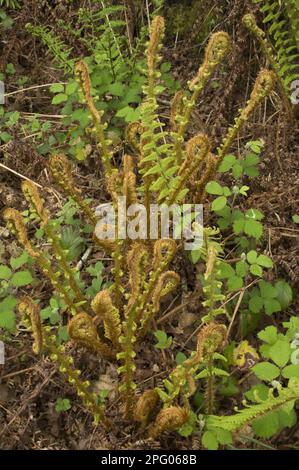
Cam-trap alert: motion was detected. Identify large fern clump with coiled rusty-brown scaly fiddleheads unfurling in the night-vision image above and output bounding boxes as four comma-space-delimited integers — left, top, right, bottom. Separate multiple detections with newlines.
4, 17, 280, 444
